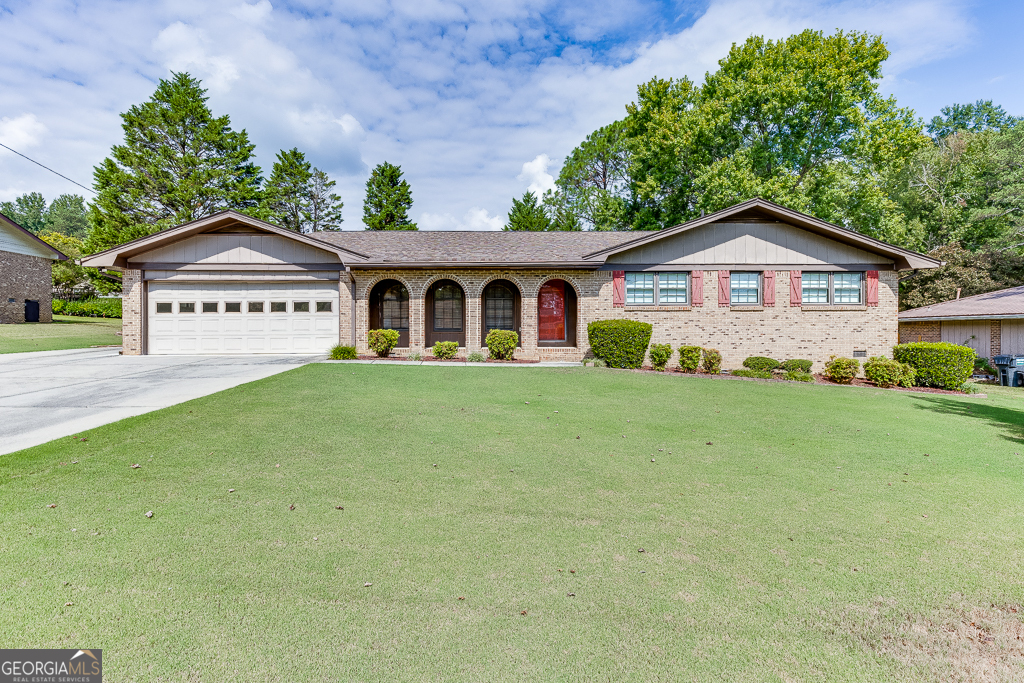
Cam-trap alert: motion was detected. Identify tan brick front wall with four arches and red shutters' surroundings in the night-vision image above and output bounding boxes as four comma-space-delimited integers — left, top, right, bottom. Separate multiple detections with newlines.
352, 269, 897, 370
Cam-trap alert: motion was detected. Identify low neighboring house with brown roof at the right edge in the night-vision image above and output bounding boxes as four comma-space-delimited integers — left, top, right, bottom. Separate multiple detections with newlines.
899, 287, 1024, 358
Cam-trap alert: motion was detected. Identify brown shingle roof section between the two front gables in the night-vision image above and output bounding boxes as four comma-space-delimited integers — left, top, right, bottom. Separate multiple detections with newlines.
310, 230, 650, 265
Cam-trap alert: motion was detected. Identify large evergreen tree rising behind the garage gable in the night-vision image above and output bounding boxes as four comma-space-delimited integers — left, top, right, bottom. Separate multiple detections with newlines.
86, 74, 261, 251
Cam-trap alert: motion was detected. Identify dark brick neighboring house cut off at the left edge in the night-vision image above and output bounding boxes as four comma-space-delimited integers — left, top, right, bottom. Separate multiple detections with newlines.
0, 214, 68, 324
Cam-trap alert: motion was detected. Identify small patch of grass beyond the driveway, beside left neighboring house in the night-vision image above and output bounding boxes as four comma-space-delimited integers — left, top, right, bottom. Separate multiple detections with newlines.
0, 315, 121, 353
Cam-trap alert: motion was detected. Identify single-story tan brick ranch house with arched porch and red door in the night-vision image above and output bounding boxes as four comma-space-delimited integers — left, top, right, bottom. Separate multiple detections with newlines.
83, 200, 940, 368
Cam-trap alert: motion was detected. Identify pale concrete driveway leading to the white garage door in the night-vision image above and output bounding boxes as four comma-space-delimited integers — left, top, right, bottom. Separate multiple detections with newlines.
0, 348, 323, 454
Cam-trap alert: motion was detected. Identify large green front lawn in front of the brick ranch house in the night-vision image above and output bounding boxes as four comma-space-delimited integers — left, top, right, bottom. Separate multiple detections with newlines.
0, 365, 1024, 682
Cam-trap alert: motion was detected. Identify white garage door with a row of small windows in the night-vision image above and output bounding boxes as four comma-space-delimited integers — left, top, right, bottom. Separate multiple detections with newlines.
148, 282, 338, 354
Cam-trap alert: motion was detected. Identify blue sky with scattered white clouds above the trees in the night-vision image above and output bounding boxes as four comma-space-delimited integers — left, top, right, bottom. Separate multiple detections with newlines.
0, 0, 1024, 229
